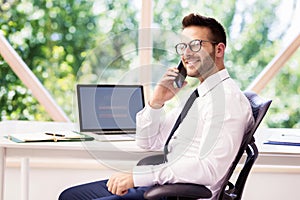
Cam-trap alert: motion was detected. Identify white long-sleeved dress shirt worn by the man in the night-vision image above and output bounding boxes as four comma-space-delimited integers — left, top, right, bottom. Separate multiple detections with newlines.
133, 69, 254, 199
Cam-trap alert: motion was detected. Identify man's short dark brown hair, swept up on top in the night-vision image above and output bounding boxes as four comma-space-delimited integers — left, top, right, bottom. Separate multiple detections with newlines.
182, 13, 226, 46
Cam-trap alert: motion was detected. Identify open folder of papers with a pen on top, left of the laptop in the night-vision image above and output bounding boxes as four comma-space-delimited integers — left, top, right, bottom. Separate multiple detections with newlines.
5, 131, 94, 143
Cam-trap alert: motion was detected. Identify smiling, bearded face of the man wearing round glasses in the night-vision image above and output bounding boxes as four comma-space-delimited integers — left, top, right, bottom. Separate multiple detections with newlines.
182, 26, 217, 81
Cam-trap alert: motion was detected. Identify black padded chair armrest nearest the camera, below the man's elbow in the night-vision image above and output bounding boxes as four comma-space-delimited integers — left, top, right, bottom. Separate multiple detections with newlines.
144, 183, 212, 200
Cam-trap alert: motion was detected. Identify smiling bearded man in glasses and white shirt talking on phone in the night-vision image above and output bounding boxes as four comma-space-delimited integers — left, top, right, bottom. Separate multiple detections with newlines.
60, 14, 253, 200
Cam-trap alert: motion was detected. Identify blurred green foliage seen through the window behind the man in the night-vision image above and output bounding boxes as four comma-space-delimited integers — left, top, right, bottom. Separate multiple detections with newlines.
0, 0, 300, 127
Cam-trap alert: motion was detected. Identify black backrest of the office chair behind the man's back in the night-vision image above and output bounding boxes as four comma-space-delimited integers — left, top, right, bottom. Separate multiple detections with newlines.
219, 91, 272, 200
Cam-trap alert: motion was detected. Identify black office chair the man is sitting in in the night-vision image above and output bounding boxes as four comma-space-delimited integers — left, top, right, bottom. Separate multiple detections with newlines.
137, 91, 272, 200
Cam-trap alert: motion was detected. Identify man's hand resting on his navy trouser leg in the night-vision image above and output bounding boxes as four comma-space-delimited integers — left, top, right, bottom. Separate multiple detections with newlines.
106, 173, 134, 196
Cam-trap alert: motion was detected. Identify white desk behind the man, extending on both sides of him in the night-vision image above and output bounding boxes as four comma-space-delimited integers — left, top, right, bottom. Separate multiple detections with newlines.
0, 121, 300, 200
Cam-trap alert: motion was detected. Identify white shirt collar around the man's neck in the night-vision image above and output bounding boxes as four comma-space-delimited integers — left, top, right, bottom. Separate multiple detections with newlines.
197, 69, 230, 97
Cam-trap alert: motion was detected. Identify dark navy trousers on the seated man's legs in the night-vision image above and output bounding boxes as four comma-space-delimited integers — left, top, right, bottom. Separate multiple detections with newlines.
59, 180, 150, 200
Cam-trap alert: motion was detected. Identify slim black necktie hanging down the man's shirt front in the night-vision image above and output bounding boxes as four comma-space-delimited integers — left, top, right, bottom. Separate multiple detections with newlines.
164, 89, 199, 162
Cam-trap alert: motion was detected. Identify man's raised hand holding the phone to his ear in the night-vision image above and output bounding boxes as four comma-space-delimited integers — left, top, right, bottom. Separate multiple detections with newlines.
149, 67, 187, 108
